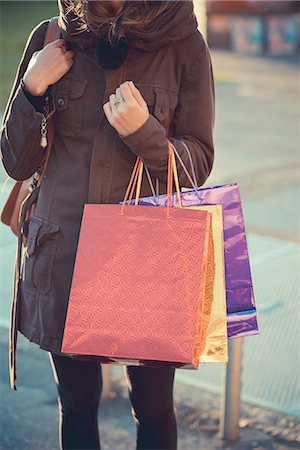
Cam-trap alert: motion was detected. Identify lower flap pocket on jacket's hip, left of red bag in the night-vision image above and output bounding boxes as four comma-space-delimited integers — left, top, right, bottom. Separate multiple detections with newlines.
22, 216, 59, 295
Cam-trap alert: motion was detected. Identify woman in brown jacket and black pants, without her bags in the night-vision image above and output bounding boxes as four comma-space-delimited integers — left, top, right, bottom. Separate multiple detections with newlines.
1, 0, 215, 449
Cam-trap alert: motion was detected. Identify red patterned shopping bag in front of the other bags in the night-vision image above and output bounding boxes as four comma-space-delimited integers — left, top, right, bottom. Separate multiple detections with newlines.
61, 146, 214, 369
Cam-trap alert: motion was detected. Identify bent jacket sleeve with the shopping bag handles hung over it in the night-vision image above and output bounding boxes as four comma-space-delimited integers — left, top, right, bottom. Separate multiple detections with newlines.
120, 33, 215, 187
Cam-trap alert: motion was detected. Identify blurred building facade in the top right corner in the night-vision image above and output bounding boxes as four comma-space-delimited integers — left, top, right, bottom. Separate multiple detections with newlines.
206, 0, 300, 55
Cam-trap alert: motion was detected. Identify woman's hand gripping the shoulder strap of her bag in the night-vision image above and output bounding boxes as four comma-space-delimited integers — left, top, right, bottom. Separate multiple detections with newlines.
23, 39, 74, 95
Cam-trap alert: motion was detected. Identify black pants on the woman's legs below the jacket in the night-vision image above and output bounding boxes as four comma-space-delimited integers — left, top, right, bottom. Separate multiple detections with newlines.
49, 352, 177, 450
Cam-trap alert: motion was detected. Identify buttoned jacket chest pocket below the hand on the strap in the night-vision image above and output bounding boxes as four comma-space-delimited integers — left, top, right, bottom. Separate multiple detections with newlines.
54, 77, 88, 137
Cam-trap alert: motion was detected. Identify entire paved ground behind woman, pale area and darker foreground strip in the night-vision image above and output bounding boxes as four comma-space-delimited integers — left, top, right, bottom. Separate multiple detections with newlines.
0, 51, 300, 450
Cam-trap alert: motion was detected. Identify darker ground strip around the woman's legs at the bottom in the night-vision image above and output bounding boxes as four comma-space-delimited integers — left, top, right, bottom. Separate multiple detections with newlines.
0, 329, 300, 450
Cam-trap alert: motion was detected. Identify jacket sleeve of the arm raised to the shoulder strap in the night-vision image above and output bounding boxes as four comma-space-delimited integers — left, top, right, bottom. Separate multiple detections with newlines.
0, 20, 55, 181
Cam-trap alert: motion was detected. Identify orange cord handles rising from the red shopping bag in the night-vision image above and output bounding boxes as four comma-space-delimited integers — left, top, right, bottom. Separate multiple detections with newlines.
120, 142, 182, 217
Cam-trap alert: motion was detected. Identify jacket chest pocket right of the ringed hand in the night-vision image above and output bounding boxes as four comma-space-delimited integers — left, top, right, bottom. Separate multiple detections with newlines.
135, 83, 178, 123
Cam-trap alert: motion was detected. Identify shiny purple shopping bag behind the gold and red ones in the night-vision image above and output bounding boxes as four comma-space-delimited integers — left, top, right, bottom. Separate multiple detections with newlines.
128, 141, 258, 338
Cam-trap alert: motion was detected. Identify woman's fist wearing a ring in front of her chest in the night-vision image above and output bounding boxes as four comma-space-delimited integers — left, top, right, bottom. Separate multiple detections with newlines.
103, 81, 149, 137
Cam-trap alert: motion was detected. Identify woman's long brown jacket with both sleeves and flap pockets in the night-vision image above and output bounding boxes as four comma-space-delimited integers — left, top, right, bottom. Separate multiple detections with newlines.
1, 1, 215, 388
